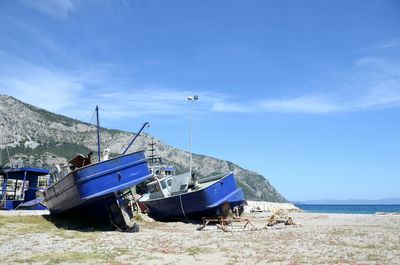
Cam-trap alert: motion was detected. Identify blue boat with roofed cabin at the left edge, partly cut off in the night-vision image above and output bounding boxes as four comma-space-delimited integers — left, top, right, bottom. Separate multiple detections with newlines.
0, 167, 49, 210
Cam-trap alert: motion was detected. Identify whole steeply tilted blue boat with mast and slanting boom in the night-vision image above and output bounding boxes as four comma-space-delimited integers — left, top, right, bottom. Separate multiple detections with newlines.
43, 107, 151, 230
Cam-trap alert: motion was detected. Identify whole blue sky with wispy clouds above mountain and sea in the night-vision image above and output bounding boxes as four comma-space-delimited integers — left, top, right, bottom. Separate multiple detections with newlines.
0, 0, 400, 200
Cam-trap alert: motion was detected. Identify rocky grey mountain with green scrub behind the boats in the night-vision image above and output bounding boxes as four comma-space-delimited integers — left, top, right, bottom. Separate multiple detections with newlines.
0, 95, 287, 202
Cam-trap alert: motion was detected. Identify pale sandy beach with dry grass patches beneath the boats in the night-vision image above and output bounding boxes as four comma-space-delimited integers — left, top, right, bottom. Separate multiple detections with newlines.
0, 210, 400, 264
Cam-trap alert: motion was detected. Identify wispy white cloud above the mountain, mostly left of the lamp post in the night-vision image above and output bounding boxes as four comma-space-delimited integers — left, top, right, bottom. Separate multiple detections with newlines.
0, 50, 219, 121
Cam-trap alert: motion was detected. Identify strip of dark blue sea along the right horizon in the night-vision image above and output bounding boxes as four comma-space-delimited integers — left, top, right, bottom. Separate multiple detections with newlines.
295, 204, 400, 214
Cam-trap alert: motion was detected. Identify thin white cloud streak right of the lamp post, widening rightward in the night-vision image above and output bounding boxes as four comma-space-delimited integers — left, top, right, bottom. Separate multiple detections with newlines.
212, 57, 400, 113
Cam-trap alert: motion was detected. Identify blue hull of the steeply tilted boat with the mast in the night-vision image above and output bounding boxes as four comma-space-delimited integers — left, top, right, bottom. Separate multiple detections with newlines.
44, 151, 151, 215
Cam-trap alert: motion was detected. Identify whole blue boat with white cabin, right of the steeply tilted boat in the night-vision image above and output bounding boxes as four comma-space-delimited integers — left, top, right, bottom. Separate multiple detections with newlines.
139, 172, 246, 220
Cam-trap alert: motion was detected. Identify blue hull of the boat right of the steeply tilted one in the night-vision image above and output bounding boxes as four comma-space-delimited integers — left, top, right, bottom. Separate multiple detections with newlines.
142, 170, 245, 220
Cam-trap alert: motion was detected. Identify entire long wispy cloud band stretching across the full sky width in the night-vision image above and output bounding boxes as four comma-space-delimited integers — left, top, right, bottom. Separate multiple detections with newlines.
0, 48, 400, 119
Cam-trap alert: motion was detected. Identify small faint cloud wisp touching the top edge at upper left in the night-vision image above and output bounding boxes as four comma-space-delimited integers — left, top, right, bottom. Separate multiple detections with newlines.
20, 0, 77, 18
